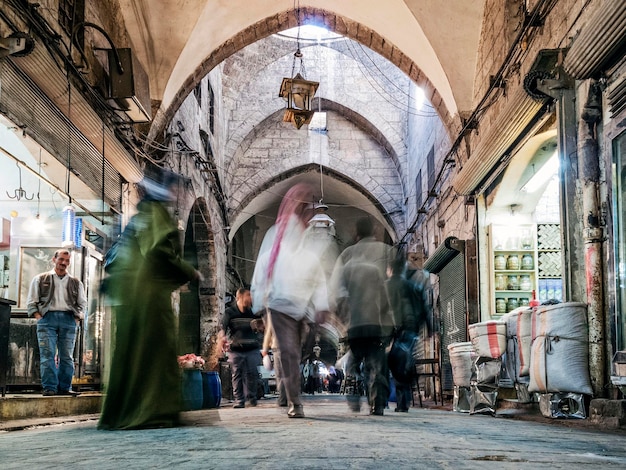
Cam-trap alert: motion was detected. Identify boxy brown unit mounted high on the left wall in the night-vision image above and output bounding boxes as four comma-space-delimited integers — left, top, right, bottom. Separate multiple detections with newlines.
108, 48, 152, 122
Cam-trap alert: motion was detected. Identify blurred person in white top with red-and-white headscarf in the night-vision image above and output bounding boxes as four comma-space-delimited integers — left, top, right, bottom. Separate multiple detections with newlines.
251, 183, 328, 418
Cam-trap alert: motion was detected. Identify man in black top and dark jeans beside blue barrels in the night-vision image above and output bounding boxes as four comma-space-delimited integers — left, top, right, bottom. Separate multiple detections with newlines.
218, 287, 261, 408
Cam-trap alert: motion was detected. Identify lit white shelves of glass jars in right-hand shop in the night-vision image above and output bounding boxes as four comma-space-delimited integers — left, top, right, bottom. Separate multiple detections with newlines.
489, 224, 537, 318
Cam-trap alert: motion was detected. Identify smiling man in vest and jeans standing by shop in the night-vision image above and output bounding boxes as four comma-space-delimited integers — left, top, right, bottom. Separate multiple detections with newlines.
27, 249, 87, 396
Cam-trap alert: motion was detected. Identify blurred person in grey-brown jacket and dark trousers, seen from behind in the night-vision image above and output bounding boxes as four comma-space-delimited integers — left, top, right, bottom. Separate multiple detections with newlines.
331, 217, 394, 416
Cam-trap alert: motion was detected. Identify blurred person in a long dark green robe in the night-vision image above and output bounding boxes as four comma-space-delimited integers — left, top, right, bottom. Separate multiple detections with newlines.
98, 168, 202, 430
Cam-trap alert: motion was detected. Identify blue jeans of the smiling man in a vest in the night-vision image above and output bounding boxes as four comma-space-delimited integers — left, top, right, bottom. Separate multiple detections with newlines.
37, 311, 76, 392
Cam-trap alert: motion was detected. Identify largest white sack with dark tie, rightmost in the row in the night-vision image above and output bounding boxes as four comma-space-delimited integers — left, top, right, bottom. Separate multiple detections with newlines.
528, 302, 593, 395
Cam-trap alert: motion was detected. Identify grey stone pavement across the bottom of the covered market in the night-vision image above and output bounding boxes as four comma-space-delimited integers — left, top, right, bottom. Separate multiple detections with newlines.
0, 395, 626, 470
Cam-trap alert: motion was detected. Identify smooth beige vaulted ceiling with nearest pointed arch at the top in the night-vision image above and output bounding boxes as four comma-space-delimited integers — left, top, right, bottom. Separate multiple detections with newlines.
119, 0, 484, 138
